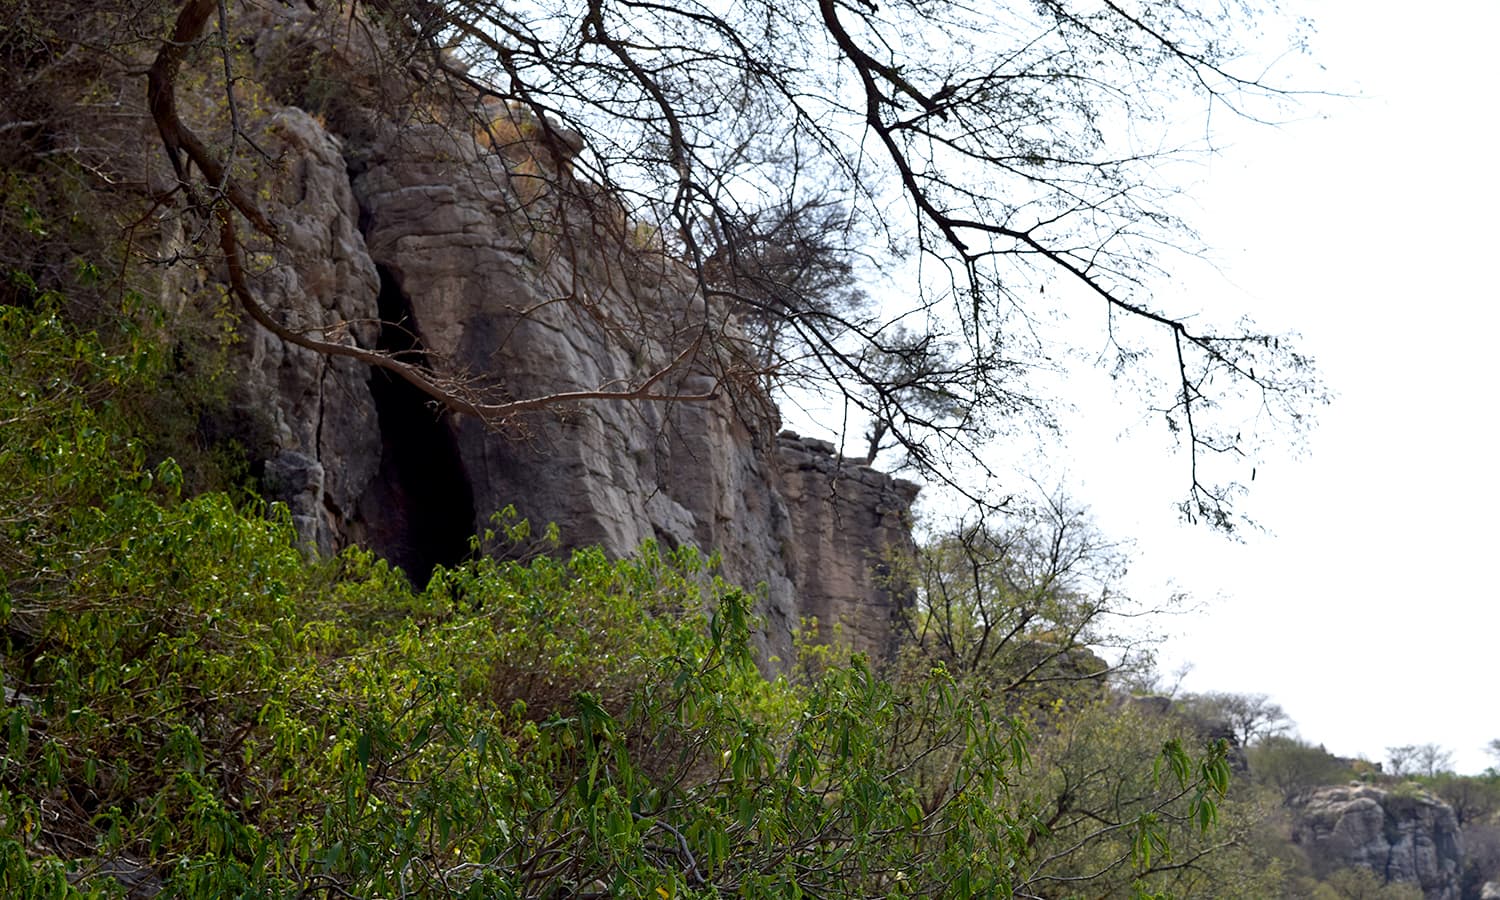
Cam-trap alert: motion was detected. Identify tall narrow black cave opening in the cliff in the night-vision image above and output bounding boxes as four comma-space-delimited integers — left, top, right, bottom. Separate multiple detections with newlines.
366, 266, 474, 588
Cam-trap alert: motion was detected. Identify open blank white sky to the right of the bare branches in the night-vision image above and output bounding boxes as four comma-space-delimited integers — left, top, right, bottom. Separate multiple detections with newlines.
1065, 0, 1500, 773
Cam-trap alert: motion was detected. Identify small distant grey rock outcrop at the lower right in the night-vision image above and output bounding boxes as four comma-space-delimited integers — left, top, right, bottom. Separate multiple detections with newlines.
1292, 785, 1463, 900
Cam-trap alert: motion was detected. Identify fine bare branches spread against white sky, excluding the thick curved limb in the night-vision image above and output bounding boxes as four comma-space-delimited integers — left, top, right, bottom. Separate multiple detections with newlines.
399, 0, 1322, 528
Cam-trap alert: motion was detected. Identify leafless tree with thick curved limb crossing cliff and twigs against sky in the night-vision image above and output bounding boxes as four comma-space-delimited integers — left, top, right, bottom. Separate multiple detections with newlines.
11, 0, 1323, 528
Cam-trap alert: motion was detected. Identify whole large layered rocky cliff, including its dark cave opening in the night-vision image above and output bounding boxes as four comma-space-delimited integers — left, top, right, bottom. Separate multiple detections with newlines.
143, 3, 917, 659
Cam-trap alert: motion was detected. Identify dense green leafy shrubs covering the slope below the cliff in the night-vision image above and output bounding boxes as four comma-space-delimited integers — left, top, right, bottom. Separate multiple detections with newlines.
0, 297, 1248, 897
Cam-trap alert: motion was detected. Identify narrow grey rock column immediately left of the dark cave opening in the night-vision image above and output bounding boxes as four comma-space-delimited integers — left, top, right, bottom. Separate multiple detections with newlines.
214, 108, 381, 551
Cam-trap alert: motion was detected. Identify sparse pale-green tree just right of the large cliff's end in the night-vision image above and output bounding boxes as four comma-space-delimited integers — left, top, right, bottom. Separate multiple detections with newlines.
893, 497, 1280, 897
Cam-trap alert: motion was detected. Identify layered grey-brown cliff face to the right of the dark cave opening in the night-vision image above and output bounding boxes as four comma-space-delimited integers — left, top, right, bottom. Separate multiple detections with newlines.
342, 112, 917, 659
